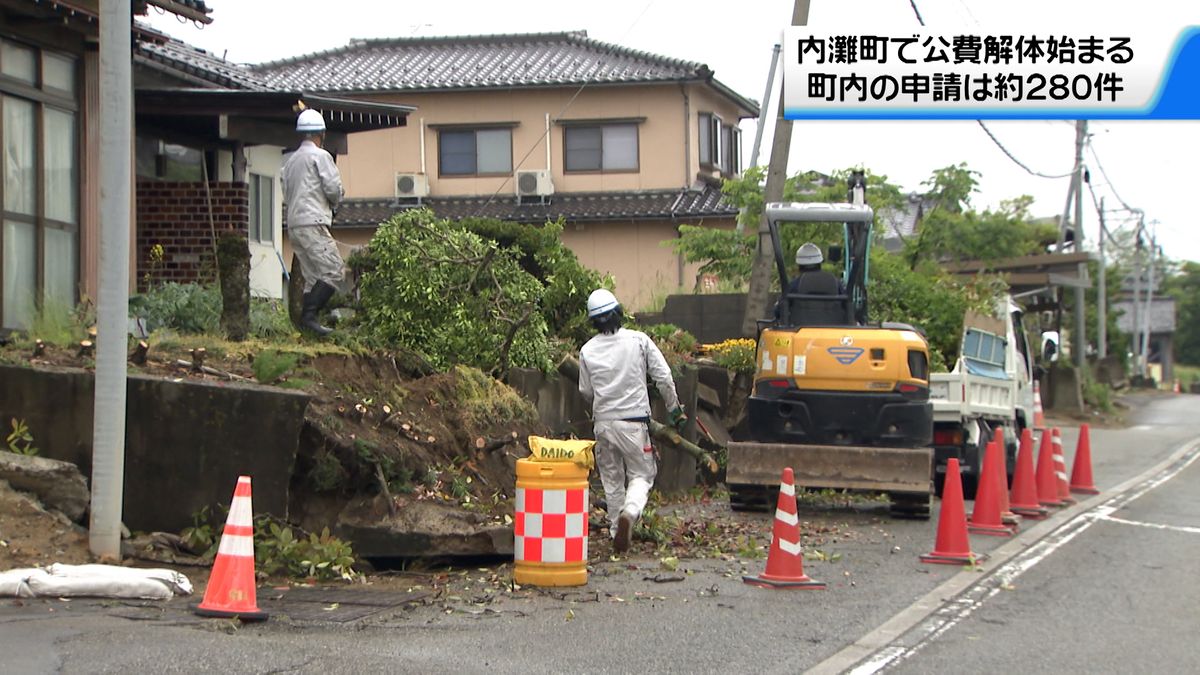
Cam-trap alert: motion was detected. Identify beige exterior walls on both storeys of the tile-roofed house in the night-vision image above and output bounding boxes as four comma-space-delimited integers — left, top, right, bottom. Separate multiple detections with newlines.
319, 79, 752, 311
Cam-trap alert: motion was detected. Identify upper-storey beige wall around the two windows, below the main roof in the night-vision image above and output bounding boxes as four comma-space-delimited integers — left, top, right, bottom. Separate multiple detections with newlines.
338, 84, 738, 197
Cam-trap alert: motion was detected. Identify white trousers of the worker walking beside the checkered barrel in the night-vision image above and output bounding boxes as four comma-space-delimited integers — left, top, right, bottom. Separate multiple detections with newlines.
592, 420, 659, 532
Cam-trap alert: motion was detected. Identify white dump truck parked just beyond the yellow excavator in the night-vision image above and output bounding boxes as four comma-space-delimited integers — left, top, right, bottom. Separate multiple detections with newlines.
929, 294, 1037, 500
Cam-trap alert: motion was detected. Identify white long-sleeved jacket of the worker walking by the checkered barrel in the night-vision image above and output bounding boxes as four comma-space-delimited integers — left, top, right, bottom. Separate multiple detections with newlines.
580, 328, 679, 420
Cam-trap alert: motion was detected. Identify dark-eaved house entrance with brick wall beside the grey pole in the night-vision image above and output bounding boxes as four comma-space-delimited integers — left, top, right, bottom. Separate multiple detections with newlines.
134, 36, 412, 298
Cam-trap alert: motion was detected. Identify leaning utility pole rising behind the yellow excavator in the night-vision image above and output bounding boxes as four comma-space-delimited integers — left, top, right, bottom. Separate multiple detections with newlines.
742, 0, 810, 336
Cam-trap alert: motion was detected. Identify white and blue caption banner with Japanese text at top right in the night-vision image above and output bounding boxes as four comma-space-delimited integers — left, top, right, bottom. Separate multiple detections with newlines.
784, 25, 1200, 120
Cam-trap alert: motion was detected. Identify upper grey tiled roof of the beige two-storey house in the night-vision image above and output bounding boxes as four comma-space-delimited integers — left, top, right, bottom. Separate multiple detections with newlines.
251, 31, 758, 114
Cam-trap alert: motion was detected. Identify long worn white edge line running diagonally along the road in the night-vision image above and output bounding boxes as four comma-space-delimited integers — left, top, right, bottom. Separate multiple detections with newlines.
809, 432, 1200, 675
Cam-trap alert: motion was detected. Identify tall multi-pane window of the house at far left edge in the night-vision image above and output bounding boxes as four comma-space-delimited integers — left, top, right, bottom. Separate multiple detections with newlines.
0, 40, 79, 329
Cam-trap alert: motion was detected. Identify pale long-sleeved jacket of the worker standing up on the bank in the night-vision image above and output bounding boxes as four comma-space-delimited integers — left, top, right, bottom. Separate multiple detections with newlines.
282, 141, 344, 228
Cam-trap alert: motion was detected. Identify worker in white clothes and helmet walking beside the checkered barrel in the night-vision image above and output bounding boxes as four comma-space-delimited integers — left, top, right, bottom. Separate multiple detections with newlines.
580, 288, 688, 552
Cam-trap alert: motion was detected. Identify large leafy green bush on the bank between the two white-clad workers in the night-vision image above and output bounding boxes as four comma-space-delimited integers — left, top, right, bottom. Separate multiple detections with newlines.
355, 209, 551, 374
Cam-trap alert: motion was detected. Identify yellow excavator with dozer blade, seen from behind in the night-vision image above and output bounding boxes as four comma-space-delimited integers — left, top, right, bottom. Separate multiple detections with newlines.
726, 173, 934, 518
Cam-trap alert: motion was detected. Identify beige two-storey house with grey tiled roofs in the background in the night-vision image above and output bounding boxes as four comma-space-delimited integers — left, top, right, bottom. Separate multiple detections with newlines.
251, 32, 758, 309
